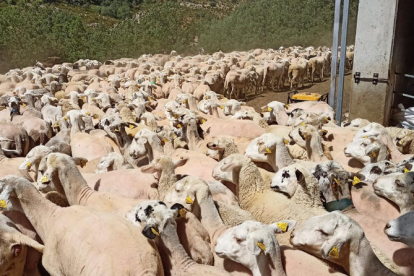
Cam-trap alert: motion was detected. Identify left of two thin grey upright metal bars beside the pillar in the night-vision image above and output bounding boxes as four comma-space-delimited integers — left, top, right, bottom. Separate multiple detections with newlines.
329, 0, 341, 108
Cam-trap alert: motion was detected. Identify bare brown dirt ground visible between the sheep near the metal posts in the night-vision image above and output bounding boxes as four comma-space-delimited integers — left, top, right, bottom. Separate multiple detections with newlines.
246, 73, 353, 115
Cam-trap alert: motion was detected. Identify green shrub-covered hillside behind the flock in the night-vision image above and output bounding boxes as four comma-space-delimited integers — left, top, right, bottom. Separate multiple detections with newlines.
0, 0, 358, 72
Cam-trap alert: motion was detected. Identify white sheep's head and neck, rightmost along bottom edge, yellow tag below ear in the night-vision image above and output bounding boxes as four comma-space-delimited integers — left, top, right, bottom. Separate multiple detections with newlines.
290, 211, 398, 276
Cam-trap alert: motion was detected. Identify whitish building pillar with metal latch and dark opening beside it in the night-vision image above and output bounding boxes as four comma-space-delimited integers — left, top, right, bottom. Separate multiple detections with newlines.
349, 0, 414, 125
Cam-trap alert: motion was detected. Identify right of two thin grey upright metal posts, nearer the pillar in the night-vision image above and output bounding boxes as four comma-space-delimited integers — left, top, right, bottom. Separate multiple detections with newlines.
336, 0, 349, 125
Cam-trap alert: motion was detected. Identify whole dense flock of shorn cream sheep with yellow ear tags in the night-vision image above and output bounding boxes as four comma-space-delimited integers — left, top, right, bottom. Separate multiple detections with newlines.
0, 47, 414, 276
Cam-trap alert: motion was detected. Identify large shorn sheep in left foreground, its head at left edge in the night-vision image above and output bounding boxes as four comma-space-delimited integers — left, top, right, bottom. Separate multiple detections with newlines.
0, 176, 164, 276
